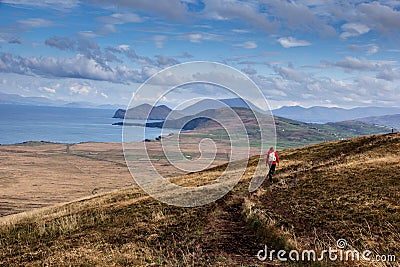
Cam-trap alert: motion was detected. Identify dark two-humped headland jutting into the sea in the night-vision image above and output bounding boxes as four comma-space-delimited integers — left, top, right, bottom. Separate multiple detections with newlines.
113, 104, 183, 120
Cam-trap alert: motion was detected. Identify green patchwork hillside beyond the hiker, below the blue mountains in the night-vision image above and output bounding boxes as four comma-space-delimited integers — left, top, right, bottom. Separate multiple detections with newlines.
139, 108, 391, 149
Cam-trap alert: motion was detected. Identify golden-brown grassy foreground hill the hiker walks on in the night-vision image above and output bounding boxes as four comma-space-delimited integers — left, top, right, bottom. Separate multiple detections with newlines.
0, 134, 400, 266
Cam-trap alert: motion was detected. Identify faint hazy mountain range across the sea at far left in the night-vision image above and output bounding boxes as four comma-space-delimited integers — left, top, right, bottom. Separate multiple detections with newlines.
0, 93, 118, 109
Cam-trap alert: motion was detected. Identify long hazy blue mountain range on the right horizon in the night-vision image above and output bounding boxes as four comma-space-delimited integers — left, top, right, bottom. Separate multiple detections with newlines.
272, 106, 400, 123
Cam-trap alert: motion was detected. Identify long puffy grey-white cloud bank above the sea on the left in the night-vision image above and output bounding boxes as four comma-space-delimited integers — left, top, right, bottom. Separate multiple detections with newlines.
0, 49, 185, 83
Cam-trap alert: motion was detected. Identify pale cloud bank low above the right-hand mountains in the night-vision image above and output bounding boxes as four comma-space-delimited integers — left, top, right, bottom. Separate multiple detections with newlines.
252, 64, 400, 107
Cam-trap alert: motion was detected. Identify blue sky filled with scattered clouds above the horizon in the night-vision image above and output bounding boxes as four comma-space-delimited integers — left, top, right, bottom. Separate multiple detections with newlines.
0, 0, 400, 108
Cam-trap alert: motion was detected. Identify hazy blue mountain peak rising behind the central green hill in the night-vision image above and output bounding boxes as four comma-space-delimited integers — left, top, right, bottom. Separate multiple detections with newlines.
181, 98, 261, 115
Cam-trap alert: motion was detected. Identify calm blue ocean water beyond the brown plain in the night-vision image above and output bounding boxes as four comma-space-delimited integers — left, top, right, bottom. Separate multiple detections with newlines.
0, 104, 176, 144
